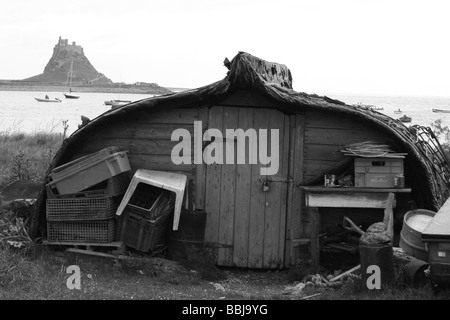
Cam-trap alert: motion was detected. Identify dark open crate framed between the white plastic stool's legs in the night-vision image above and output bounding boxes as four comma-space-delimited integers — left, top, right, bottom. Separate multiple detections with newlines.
127, 183, 175, 220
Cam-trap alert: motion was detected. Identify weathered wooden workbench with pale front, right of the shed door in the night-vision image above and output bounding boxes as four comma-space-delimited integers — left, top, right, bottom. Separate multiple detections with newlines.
300, 186, 411, 272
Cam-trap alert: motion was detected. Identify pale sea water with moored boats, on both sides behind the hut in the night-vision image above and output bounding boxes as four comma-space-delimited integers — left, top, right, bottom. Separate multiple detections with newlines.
0, 91, 450, 135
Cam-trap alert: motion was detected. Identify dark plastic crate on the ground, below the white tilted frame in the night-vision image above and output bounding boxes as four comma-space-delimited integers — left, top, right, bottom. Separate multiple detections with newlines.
119, 206, 173, 252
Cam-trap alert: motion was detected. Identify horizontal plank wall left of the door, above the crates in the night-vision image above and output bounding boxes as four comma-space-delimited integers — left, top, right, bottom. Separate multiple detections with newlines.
73, 108, 200, 206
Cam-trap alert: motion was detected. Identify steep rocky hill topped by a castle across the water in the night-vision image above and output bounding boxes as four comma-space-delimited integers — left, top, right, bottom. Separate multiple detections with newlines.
24, 37, 112, 85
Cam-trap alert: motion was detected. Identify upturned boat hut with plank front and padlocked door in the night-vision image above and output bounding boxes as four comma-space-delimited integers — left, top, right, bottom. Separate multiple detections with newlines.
31, 52, 450, 268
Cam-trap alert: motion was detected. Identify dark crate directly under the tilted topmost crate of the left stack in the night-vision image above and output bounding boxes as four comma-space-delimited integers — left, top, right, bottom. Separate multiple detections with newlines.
46, 172, 130, 199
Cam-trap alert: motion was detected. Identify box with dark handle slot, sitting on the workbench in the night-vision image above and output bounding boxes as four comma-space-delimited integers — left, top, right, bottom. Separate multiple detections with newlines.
355, 157, 405, 188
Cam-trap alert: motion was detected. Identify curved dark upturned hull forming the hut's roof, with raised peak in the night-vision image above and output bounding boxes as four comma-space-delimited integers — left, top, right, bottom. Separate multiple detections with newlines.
31, 52, 450, 236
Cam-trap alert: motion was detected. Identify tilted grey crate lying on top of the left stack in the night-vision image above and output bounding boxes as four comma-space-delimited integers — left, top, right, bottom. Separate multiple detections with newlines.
47, 151, 131, 195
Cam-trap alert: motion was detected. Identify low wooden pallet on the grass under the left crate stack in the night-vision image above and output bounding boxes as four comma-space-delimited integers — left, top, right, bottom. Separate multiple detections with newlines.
43, 240, 126, 259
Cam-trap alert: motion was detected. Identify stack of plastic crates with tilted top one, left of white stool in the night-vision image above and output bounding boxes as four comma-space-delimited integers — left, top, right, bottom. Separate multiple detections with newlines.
46, 147, 130, 243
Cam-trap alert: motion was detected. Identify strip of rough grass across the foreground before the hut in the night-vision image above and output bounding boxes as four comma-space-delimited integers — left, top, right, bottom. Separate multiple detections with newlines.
0, 245, 450, 300
